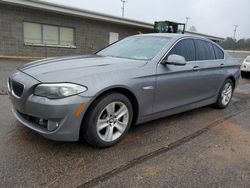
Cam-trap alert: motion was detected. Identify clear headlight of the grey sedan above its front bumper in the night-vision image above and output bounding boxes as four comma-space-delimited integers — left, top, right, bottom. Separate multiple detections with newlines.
34, 83, 87, 99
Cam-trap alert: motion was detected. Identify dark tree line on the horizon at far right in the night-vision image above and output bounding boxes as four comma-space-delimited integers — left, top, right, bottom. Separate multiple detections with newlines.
220, 37, 250, 50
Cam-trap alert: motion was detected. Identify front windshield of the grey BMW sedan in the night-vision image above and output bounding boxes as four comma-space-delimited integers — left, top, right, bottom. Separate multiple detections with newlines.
96, 36, 171, 60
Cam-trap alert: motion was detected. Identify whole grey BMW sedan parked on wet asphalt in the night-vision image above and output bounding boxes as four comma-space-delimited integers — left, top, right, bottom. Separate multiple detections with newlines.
8, 34, 240, 147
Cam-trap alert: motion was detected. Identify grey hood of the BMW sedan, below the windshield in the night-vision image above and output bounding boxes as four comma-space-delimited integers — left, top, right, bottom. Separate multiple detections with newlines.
18, 55, 147, 82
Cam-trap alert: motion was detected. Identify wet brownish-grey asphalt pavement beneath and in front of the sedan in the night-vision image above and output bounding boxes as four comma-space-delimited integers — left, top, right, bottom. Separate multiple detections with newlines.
0, 55, 250, 188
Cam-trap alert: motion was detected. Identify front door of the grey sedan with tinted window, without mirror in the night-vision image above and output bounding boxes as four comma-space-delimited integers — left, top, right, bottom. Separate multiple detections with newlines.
153, 39, 202, 113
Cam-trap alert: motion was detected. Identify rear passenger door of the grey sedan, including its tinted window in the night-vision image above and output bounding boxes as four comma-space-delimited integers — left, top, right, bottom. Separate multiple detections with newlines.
194, 39, 225, 99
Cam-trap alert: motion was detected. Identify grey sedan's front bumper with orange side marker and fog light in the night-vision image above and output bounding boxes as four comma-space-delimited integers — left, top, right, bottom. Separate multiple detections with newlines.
8, 72, 91, 141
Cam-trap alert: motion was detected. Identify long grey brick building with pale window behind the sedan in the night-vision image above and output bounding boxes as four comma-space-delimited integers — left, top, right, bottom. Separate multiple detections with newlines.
0, 0, 223, 58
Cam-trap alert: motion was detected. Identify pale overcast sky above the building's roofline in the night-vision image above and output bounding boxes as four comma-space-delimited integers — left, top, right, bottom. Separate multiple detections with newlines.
41, 0, 250, 39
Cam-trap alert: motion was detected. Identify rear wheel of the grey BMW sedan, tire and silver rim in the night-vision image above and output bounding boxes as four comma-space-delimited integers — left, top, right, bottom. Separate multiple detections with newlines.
214, 79, 234, 109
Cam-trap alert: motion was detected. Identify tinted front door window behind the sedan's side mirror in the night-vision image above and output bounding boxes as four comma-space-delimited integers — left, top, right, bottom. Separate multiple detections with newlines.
167, 39, 195, 61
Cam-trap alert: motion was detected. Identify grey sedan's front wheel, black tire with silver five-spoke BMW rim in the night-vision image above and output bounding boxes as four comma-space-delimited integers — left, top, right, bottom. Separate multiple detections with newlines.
83, 93, 133, 148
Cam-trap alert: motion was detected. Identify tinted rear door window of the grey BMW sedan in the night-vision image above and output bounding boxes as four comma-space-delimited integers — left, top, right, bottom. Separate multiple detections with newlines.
195, 40, 215, 61
